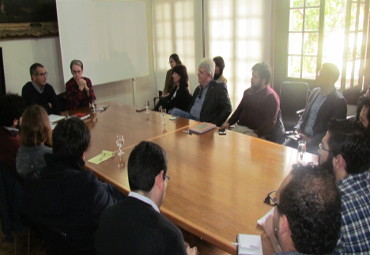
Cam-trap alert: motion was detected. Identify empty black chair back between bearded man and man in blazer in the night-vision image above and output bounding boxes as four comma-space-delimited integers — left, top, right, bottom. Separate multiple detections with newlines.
280, 81, 309, 131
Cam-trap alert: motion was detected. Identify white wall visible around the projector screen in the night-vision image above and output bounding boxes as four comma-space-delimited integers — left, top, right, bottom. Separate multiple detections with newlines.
0, 0, 157, 106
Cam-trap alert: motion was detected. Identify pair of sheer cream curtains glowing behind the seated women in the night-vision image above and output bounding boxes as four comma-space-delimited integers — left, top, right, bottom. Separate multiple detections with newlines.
153, 0, 272, 106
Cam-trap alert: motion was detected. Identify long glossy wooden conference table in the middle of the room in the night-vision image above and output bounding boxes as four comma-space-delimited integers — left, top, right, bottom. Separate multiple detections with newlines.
73, 104, 315, 254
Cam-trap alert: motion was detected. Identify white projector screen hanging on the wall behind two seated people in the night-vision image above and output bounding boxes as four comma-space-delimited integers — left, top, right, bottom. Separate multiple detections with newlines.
57, 0, 149, 85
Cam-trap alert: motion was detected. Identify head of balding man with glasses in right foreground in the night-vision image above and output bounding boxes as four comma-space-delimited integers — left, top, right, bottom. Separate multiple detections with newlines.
263, 165, 340, 255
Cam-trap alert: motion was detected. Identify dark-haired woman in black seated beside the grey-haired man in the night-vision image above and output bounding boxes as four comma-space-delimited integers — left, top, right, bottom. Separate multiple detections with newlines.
154, 65, 192, 112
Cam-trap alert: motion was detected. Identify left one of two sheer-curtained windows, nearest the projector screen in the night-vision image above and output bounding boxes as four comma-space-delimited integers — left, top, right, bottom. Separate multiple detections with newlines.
153, 0, 196, 90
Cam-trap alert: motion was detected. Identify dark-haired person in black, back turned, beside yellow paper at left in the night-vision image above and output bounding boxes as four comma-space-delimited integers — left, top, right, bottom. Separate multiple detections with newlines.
22, 117, 123, 254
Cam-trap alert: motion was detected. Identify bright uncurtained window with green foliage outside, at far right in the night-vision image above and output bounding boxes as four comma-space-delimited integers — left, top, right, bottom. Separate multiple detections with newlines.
287, 0, 369, 89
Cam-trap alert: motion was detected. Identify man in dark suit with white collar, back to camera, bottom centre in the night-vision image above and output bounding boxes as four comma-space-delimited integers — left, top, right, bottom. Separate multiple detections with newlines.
95, 142, 197, 255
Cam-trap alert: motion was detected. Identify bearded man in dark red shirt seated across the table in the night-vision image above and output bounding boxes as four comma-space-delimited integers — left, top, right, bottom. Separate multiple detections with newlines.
221, 63, 284, 142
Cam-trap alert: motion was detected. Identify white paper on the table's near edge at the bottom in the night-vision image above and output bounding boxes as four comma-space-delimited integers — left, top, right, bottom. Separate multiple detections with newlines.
236, 234, 263, 255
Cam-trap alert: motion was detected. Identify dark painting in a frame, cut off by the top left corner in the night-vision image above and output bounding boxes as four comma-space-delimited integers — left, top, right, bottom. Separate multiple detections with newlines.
0, 0, 58, 40
